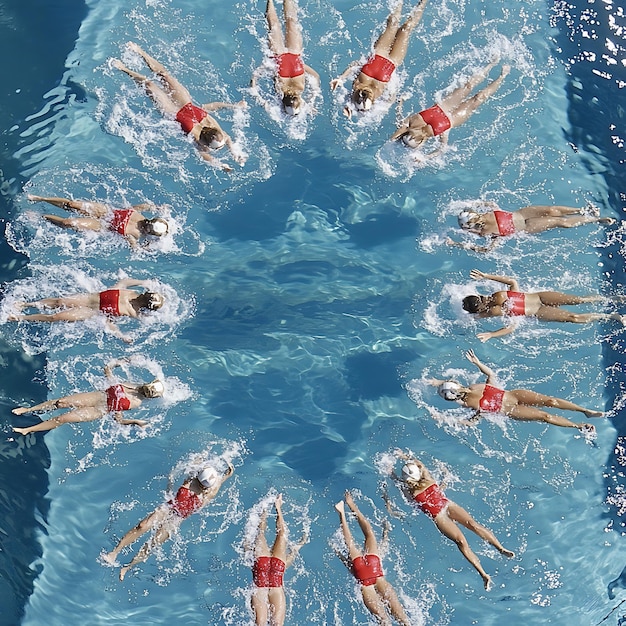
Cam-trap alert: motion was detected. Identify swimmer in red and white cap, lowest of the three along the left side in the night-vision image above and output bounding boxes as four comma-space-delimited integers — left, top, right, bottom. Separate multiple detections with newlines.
12, 360, 165, 435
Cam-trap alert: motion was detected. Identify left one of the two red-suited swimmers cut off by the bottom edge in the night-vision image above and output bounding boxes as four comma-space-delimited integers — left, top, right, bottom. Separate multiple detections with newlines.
246, 493, 308, 626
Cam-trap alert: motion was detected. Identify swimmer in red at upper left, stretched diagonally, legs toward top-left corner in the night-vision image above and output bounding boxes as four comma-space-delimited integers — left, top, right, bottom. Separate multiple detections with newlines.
112, 41, 246, 172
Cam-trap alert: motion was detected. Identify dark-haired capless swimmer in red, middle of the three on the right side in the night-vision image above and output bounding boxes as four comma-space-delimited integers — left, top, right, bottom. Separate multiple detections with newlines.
463, 270, 626, 342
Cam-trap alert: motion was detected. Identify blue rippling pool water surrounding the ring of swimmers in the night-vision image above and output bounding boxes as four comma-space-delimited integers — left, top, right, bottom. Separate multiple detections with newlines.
0, 0, 626, 626
